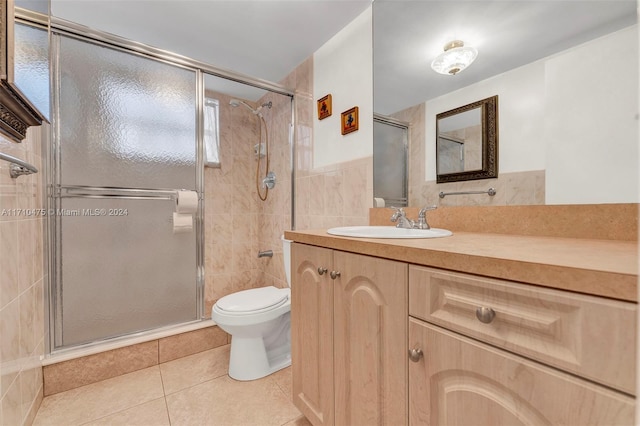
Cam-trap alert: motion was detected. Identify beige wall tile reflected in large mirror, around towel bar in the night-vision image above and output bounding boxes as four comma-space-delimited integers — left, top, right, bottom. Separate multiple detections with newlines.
393, 104, 545, 207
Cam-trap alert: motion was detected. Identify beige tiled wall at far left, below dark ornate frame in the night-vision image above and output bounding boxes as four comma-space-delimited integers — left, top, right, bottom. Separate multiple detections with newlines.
0, 126, 46, 425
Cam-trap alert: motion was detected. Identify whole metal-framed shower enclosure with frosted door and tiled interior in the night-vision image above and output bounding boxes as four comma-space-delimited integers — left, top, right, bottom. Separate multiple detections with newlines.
48, 19, 294, 353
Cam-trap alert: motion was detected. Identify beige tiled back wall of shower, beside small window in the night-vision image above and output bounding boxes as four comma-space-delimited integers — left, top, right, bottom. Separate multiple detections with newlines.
204, 93, 260, 317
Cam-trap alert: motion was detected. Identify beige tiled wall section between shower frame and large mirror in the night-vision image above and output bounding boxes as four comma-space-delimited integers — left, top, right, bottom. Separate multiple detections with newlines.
295, 59, 373, 230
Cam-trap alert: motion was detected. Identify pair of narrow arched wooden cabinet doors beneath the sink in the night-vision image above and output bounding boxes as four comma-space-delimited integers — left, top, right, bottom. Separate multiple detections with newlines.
291, 243, 408, 426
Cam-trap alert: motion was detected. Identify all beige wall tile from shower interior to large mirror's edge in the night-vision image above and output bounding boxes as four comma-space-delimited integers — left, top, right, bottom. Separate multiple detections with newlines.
205, 57, 373, 310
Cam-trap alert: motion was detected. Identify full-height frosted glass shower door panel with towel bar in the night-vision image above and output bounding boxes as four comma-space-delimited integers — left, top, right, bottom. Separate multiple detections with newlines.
52, 35, 200, 349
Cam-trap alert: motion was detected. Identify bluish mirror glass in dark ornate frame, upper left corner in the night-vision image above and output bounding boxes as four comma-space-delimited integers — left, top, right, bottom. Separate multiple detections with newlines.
14, 23, 49, 120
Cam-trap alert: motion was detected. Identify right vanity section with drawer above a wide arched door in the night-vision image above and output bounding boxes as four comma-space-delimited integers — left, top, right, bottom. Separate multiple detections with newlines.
408, 265, 637, 426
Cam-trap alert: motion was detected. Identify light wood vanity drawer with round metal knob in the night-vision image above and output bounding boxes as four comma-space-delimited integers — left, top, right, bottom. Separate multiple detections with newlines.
409, 265, 637, 394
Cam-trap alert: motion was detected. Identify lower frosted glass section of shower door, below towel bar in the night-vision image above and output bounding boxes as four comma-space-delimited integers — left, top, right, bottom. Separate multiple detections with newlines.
61, 197, 197, 346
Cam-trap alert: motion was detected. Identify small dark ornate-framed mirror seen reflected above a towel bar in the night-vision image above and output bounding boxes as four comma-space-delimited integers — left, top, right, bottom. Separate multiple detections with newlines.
436, 96, 498, 183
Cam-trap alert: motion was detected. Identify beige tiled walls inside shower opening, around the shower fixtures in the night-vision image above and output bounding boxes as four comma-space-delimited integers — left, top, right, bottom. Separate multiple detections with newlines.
205, 80, 291, 317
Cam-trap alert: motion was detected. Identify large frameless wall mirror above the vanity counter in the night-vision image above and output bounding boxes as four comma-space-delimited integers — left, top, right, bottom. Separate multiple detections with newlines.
373, 0, 640, 207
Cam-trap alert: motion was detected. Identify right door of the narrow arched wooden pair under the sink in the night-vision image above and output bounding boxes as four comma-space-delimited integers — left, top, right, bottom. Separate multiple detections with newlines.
333, 251, 408, 426
